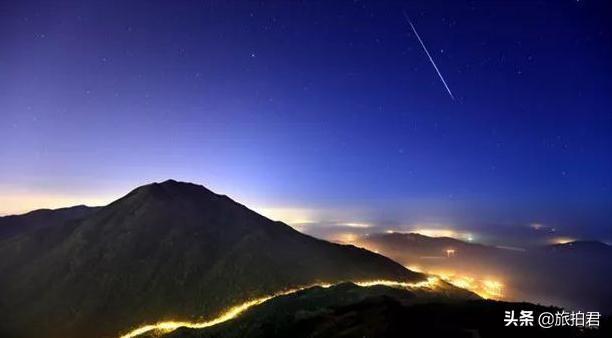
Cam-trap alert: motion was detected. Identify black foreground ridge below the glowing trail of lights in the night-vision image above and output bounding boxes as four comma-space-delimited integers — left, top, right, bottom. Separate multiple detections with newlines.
160, 283, 611, 338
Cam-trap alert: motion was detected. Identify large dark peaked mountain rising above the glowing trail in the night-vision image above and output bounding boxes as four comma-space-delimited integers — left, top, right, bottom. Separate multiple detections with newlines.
0, 180, 424, 338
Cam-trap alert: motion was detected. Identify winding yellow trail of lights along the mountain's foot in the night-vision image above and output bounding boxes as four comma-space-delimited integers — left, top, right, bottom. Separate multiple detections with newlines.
120, 277, 439, 338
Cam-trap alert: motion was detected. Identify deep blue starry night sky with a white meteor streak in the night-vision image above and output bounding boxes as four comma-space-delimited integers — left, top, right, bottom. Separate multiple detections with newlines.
0, 0, 612, 241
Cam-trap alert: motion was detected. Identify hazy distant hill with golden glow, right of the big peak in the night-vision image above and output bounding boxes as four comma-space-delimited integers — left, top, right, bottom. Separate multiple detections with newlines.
359, 233, 612, 314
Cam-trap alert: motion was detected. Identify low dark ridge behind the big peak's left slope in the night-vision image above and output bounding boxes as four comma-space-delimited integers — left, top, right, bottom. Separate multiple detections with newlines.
0, 205, 98, 240
